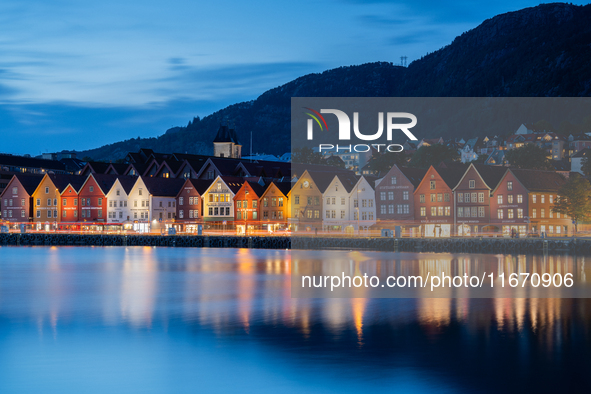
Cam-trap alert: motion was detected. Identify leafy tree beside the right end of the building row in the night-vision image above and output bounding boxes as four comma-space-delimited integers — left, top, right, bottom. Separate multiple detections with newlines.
552, 174, 591, 233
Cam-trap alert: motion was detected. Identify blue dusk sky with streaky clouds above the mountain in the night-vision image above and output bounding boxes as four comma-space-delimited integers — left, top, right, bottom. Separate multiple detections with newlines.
0, 0, 580, 155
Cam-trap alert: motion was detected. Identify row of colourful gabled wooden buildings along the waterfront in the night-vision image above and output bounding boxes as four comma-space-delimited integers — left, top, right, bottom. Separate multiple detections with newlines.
0, 158, 573, 237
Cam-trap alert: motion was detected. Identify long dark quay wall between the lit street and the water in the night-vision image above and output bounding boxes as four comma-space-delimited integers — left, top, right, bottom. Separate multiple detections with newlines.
0, 233, 591, 254
